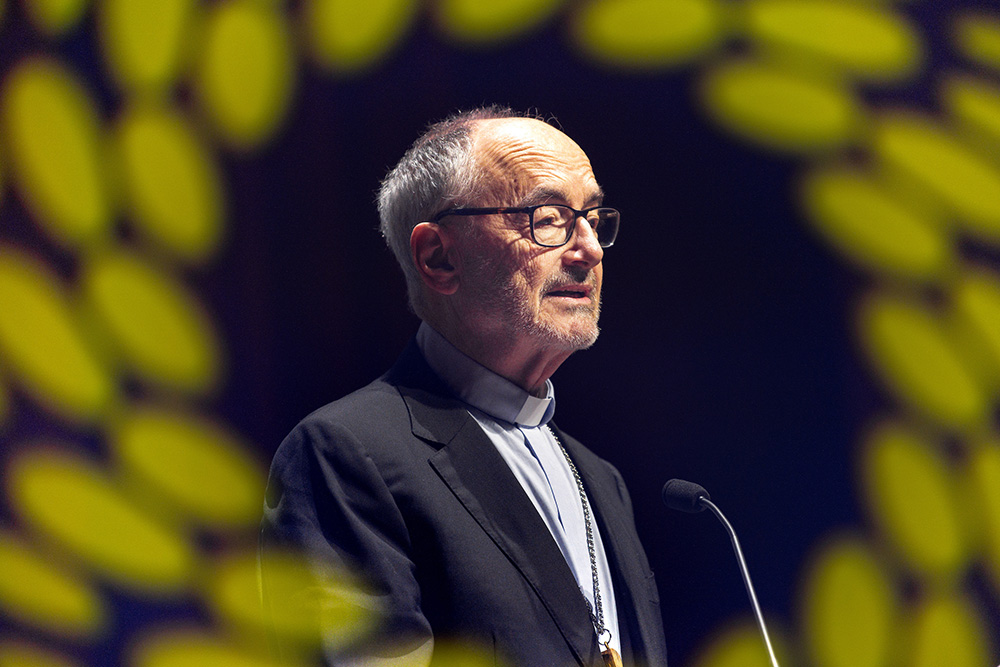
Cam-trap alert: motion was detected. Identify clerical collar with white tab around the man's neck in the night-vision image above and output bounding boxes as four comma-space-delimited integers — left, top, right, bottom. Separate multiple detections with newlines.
417, 322, 556, 427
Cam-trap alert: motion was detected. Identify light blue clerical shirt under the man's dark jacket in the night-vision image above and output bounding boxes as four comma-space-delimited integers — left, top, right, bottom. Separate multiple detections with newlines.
417, 323, 621, 652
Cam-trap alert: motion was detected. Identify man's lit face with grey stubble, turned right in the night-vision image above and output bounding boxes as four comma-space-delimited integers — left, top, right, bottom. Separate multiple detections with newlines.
460, 119, 604, 351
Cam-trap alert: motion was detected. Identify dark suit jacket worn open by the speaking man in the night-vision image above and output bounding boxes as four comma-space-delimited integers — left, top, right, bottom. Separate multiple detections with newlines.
261, 341, 666, 667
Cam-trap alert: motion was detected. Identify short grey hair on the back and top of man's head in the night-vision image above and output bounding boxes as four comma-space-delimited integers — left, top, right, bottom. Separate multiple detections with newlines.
378, 105, 534, 316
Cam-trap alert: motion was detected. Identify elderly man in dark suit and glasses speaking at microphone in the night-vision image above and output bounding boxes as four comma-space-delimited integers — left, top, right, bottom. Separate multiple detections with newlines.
261, 108, 666, 667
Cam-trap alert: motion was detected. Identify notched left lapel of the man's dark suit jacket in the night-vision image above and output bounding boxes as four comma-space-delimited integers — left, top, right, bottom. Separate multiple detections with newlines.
391, 346, 599, 665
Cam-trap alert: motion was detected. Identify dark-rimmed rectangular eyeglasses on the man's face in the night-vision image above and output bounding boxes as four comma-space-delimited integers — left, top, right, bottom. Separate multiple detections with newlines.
431, 204, 621, 248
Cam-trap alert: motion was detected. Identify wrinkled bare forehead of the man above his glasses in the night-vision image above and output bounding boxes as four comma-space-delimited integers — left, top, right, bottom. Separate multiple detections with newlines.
473, 118, 601, 206
